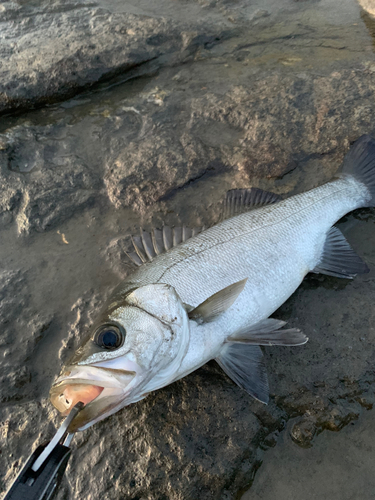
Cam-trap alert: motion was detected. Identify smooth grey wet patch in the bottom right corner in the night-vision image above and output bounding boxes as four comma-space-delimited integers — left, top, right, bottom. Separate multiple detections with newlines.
242, 412, 375, 500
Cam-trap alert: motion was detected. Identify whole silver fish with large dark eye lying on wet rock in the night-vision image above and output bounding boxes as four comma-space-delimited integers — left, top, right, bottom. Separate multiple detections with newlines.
50, 135, 375, 432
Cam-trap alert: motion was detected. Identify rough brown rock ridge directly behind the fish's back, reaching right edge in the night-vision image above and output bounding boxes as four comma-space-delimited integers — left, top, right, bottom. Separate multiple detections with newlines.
82, 64, 375, 213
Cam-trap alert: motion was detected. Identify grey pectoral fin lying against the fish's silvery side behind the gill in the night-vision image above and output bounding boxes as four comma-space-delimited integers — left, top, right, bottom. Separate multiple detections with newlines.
189, 278, 247, 323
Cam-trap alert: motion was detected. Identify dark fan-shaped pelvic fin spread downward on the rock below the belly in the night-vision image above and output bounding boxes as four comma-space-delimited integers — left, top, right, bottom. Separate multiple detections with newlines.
216, 342, 269, 404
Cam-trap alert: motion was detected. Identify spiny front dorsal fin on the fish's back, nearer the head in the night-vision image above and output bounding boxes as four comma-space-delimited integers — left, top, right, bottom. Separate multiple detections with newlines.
125, 226, 204, 266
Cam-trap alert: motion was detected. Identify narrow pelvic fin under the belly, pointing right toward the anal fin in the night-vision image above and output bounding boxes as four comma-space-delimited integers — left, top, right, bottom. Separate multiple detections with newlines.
227, 318, 309, 346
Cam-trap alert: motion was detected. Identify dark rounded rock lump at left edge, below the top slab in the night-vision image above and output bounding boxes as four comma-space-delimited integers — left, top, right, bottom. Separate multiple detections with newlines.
0, 120, 103, 233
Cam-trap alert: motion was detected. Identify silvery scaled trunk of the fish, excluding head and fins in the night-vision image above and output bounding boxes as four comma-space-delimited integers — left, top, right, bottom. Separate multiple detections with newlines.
122, 177, 369, 374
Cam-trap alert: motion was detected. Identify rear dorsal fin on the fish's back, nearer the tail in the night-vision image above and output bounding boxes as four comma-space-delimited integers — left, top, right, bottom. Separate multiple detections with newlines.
222, 188, 282, 220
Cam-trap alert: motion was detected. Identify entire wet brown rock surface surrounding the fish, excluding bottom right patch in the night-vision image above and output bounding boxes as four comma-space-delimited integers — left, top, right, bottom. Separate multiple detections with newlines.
0, 0, 375, 500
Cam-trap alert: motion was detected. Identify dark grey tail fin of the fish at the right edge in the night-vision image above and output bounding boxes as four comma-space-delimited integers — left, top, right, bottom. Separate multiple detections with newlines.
342, 135, 375, 207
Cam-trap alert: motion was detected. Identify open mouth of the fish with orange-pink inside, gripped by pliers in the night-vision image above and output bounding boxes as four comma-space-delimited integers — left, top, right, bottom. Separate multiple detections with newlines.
50, 366, 136, 432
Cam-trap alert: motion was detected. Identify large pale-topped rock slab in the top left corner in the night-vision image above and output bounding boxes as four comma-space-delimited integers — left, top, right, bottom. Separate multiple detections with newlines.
0, 0, 220, 112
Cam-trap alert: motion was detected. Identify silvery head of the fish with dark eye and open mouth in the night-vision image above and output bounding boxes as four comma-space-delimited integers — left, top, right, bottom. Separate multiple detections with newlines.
50, 283, 190, 432
